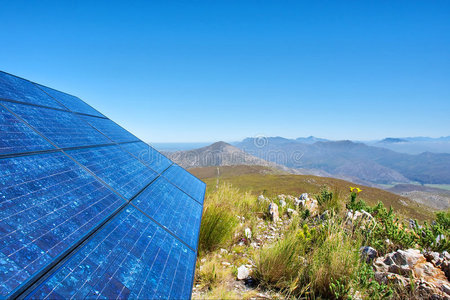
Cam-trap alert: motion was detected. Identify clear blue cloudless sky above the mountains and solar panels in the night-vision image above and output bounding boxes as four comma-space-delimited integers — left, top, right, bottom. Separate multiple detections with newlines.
0, 0, 450, 142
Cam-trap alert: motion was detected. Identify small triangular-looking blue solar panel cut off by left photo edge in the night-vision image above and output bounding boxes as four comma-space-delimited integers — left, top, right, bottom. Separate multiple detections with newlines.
0, 105, 54, 155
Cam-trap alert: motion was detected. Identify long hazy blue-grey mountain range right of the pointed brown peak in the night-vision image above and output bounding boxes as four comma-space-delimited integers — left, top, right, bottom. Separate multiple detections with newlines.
236, 138, 450, 184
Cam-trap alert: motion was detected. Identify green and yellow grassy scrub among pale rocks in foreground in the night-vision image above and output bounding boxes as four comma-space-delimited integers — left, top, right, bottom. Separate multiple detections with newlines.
194, 184, 450, 299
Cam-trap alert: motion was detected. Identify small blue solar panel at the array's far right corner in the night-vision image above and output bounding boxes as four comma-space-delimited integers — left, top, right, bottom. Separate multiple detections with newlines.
162, 165, 206, 203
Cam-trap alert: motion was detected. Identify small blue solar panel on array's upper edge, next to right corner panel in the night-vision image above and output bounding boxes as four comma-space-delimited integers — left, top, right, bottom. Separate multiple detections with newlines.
120, 142, 172, 173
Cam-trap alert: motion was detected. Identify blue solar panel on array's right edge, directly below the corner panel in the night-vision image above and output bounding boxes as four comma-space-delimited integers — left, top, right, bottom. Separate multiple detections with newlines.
132, 177, 202, 249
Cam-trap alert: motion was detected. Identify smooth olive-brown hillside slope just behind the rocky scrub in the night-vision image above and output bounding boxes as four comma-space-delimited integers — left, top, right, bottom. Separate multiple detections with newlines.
189, 166, 432, 220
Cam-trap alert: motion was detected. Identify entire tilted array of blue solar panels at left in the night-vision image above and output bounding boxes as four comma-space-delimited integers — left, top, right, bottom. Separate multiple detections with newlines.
0, 72, 205, 299
